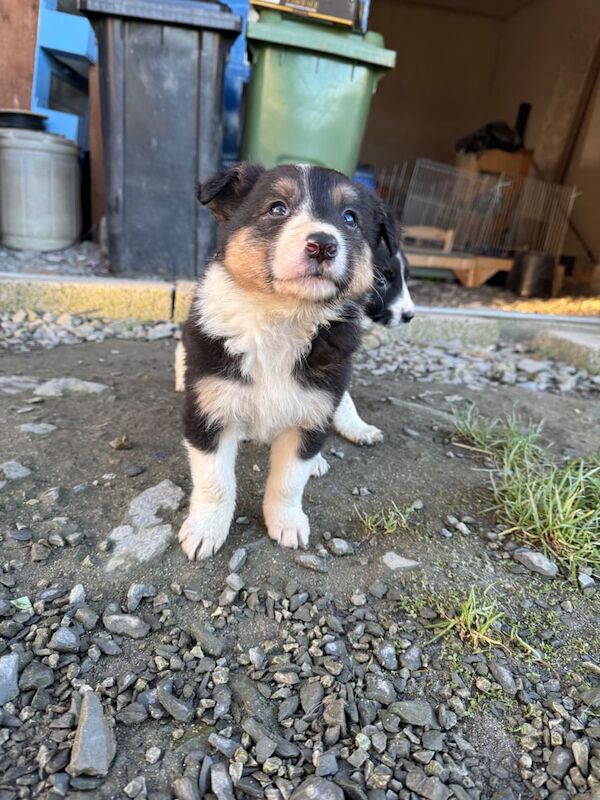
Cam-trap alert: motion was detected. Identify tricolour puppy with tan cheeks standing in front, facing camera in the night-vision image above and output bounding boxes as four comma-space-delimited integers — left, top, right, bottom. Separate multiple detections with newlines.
179, 164, 398, 560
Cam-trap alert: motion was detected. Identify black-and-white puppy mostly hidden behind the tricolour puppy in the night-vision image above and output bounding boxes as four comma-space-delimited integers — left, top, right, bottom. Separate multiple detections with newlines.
330, 244, 415, 450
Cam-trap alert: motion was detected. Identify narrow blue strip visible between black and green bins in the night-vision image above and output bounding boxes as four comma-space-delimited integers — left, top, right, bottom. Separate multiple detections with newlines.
223, 0, 251, 167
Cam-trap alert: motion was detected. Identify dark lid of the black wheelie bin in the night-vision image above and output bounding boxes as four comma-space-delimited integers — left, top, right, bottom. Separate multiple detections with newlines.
77, 0, 242, 33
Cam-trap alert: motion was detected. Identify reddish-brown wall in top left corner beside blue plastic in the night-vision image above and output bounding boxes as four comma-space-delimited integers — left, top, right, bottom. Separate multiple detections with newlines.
0, 0, 39, 109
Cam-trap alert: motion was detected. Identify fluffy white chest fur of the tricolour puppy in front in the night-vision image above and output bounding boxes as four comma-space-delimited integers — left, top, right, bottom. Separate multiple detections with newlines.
195, 265, 334, 442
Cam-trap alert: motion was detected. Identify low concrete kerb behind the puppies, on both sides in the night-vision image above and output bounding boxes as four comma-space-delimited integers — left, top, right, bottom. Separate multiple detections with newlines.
0, 273, 600, 362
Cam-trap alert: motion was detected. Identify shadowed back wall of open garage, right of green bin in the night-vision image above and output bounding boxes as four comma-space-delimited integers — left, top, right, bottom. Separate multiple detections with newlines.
361, 0, 500, 167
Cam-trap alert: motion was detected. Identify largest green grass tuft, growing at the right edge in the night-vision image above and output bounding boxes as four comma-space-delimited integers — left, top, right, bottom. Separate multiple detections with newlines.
455, 410, 600, 579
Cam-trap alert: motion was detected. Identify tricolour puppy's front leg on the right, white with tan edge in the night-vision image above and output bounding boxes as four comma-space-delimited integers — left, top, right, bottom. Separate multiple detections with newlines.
263, 428, 326, 549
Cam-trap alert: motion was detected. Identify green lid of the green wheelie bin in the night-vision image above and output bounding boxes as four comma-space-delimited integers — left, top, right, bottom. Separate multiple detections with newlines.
246, 11, 396, 69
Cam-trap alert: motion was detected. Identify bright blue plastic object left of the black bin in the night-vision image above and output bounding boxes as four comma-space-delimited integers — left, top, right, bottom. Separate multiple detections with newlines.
31, 0, 98, 150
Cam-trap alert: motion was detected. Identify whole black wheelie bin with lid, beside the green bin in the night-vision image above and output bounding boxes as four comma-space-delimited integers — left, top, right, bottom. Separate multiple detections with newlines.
79, 0, 241, 279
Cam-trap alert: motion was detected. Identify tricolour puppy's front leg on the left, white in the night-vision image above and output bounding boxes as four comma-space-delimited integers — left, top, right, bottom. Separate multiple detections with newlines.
179, 429, 238, 561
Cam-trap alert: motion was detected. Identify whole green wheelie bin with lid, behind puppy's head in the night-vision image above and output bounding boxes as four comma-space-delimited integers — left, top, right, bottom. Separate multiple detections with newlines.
242, 11, 396, 176
